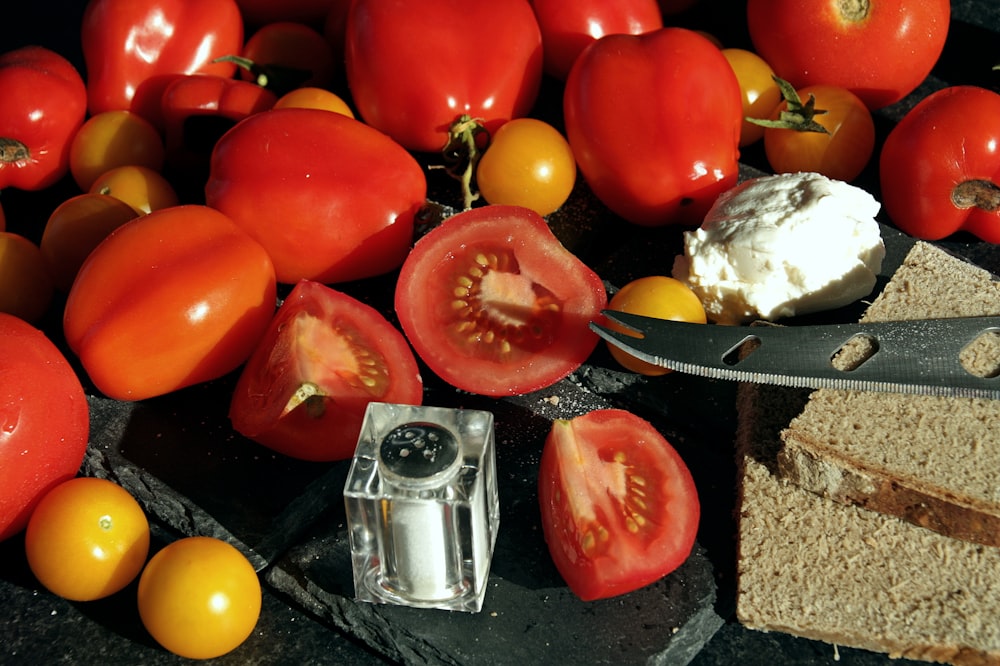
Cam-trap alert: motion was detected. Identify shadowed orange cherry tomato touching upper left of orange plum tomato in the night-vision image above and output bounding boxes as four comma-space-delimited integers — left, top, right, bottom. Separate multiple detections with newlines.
41, 193, 139, 291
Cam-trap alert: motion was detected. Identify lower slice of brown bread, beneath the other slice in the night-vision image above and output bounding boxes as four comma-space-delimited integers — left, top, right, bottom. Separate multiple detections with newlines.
736, 244, 1000, 666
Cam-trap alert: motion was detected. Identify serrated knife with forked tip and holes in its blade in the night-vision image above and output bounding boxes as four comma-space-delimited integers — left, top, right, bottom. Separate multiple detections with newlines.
590, 310, 1000, 400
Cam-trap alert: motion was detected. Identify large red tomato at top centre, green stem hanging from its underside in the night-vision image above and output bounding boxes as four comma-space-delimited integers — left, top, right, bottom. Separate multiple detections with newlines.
345, 0, 542, 152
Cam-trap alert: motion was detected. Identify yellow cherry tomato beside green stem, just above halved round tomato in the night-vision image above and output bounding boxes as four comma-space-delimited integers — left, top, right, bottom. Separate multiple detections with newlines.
476, 118, 576, 215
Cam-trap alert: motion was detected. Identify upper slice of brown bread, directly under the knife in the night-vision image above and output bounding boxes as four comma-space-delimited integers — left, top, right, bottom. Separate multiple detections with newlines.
778, 243, 1000, 546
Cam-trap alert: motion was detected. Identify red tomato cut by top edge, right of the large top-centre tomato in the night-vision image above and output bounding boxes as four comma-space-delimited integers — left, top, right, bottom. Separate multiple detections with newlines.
531, 0, 663, 81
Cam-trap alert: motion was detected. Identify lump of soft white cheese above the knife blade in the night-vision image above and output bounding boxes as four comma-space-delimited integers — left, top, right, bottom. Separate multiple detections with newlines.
673, 173, 885, 324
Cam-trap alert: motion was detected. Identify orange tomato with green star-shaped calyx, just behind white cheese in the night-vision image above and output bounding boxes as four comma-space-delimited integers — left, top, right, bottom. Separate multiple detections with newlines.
764, 85, 875, 182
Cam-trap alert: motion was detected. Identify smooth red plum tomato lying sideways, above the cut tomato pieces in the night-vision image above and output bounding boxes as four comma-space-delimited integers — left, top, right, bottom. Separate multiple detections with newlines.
205, 109, 427, 284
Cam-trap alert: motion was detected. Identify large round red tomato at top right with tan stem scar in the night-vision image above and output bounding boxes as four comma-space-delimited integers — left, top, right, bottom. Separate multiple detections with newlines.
747, 0, 951, 110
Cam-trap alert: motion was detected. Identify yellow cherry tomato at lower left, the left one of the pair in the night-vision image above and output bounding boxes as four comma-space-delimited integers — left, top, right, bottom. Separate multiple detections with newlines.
24, 477, 149, 601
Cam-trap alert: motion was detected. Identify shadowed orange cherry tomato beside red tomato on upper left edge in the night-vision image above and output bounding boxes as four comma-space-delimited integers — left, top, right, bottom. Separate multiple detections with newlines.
69, 110, 166, 192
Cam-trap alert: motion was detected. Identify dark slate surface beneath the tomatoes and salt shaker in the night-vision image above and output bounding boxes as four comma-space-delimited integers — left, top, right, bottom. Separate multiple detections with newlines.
0, 0, 1000, 666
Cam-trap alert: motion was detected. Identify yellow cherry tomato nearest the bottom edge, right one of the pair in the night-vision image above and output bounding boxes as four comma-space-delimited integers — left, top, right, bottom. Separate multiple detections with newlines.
139, 536, 261, 659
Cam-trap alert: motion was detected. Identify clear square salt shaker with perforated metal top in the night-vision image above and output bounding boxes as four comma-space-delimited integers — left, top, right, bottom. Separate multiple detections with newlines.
344, 402, 499, 612
